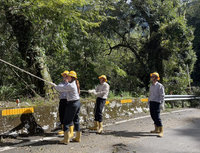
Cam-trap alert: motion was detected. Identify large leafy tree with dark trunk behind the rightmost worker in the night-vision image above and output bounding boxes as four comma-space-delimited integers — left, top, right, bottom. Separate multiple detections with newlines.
93, 0, 196, 93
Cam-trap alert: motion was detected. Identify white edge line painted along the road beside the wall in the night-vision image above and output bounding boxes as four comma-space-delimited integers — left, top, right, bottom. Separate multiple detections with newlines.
0, 109, 195, 152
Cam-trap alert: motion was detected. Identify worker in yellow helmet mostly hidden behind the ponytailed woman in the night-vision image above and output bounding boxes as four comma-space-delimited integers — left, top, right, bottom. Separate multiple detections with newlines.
55, 70, 74, 137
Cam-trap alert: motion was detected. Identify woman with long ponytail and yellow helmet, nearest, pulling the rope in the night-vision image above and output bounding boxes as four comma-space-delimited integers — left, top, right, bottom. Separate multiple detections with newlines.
51, 71, 81, 144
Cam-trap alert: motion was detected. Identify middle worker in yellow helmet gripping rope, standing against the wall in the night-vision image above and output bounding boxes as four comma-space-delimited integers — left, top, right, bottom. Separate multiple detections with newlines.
88, 75, 110, 133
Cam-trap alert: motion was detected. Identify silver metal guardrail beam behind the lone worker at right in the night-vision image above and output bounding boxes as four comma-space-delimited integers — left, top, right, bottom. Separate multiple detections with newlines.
165, 95, 200, 101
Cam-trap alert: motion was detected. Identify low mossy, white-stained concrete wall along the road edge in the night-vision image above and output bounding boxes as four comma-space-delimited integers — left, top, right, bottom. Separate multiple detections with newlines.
0, 99, 148, 134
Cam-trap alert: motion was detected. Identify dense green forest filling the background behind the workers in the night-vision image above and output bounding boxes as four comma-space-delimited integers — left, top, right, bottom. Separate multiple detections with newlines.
0, 0, 198, 100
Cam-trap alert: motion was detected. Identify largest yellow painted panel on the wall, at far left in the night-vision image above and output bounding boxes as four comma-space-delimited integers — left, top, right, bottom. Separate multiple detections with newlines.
2, 107, 34, 116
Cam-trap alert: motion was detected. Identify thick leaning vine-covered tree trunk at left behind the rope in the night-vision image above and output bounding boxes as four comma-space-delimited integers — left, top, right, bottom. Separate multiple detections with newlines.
5, 6, 54, 98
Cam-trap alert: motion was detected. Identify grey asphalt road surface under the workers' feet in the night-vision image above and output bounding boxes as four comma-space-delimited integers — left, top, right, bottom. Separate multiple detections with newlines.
0, 109, 200, 153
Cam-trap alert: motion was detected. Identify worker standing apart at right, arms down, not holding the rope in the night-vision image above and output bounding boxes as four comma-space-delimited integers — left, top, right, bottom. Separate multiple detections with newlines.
148, 72, 165, 137
